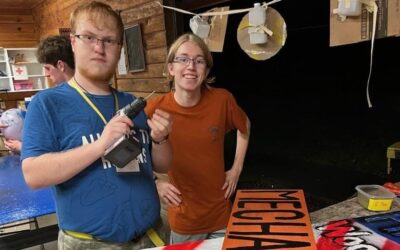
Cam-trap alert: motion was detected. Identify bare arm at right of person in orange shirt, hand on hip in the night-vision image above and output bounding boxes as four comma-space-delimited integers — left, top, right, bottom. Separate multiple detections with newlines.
222, 117, 250, 199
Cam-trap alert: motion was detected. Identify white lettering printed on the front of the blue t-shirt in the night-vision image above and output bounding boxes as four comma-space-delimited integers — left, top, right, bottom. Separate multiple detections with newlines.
82, 129, 150, 169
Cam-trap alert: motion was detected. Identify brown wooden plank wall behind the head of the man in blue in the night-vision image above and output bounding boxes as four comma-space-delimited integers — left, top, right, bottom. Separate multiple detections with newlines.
33, 0, 170, 95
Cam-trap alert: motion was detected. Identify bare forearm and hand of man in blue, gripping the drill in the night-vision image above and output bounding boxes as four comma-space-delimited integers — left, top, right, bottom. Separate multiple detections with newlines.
22, 115, 133, 188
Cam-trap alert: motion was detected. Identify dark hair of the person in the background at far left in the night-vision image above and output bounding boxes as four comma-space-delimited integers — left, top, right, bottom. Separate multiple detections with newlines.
37, 36, 75, 69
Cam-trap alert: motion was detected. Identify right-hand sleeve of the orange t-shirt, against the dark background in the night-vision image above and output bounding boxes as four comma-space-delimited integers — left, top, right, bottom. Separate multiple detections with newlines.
226, 92, 247, 134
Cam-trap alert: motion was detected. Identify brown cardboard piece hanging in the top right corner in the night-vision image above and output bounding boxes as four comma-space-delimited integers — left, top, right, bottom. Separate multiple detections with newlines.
330, 0, 400, 46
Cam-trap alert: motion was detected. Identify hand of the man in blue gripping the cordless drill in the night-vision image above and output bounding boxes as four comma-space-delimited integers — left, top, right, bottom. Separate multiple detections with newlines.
98, 115, 133, 150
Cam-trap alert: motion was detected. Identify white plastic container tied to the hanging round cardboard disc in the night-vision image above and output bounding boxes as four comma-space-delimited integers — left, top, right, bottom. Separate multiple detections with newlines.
248, 3, 268, 44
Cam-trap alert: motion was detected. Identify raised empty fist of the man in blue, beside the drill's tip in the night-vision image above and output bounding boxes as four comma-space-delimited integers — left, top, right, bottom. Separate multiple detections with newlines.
147, 109, 172, 142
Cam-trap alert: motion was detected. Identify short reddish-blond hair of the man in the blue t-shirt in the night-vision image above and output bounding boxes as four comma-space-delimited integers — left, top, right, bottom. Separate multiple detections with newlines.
70, 1, 124, 44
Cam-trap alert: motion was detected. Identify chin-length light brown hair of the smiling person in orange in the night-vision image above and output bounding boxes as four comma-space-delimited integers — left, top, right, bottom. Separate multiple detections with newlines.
165, 33, 215, 83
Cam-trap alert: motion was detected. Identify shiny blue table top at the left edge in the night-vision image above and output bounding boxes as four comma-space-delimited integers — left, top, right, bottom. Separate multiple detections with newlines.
0, 155, 55, 225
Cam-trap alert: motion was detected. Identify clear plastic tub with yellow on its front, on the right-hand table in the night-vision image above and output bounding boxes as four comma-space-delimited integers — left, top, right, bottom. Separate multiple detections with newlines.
356, 185, 396, 211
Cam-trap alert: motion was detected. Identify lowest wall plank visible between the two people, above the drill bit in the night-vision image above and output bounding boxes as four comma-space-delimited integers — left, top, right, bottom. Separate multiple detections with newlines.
117, 78, 170, 93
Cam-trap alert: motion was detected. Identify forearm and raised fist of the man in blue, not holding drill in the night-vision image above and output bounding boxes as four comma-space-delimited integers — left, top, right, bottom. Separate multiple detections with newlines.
147, 109, 172, 173
